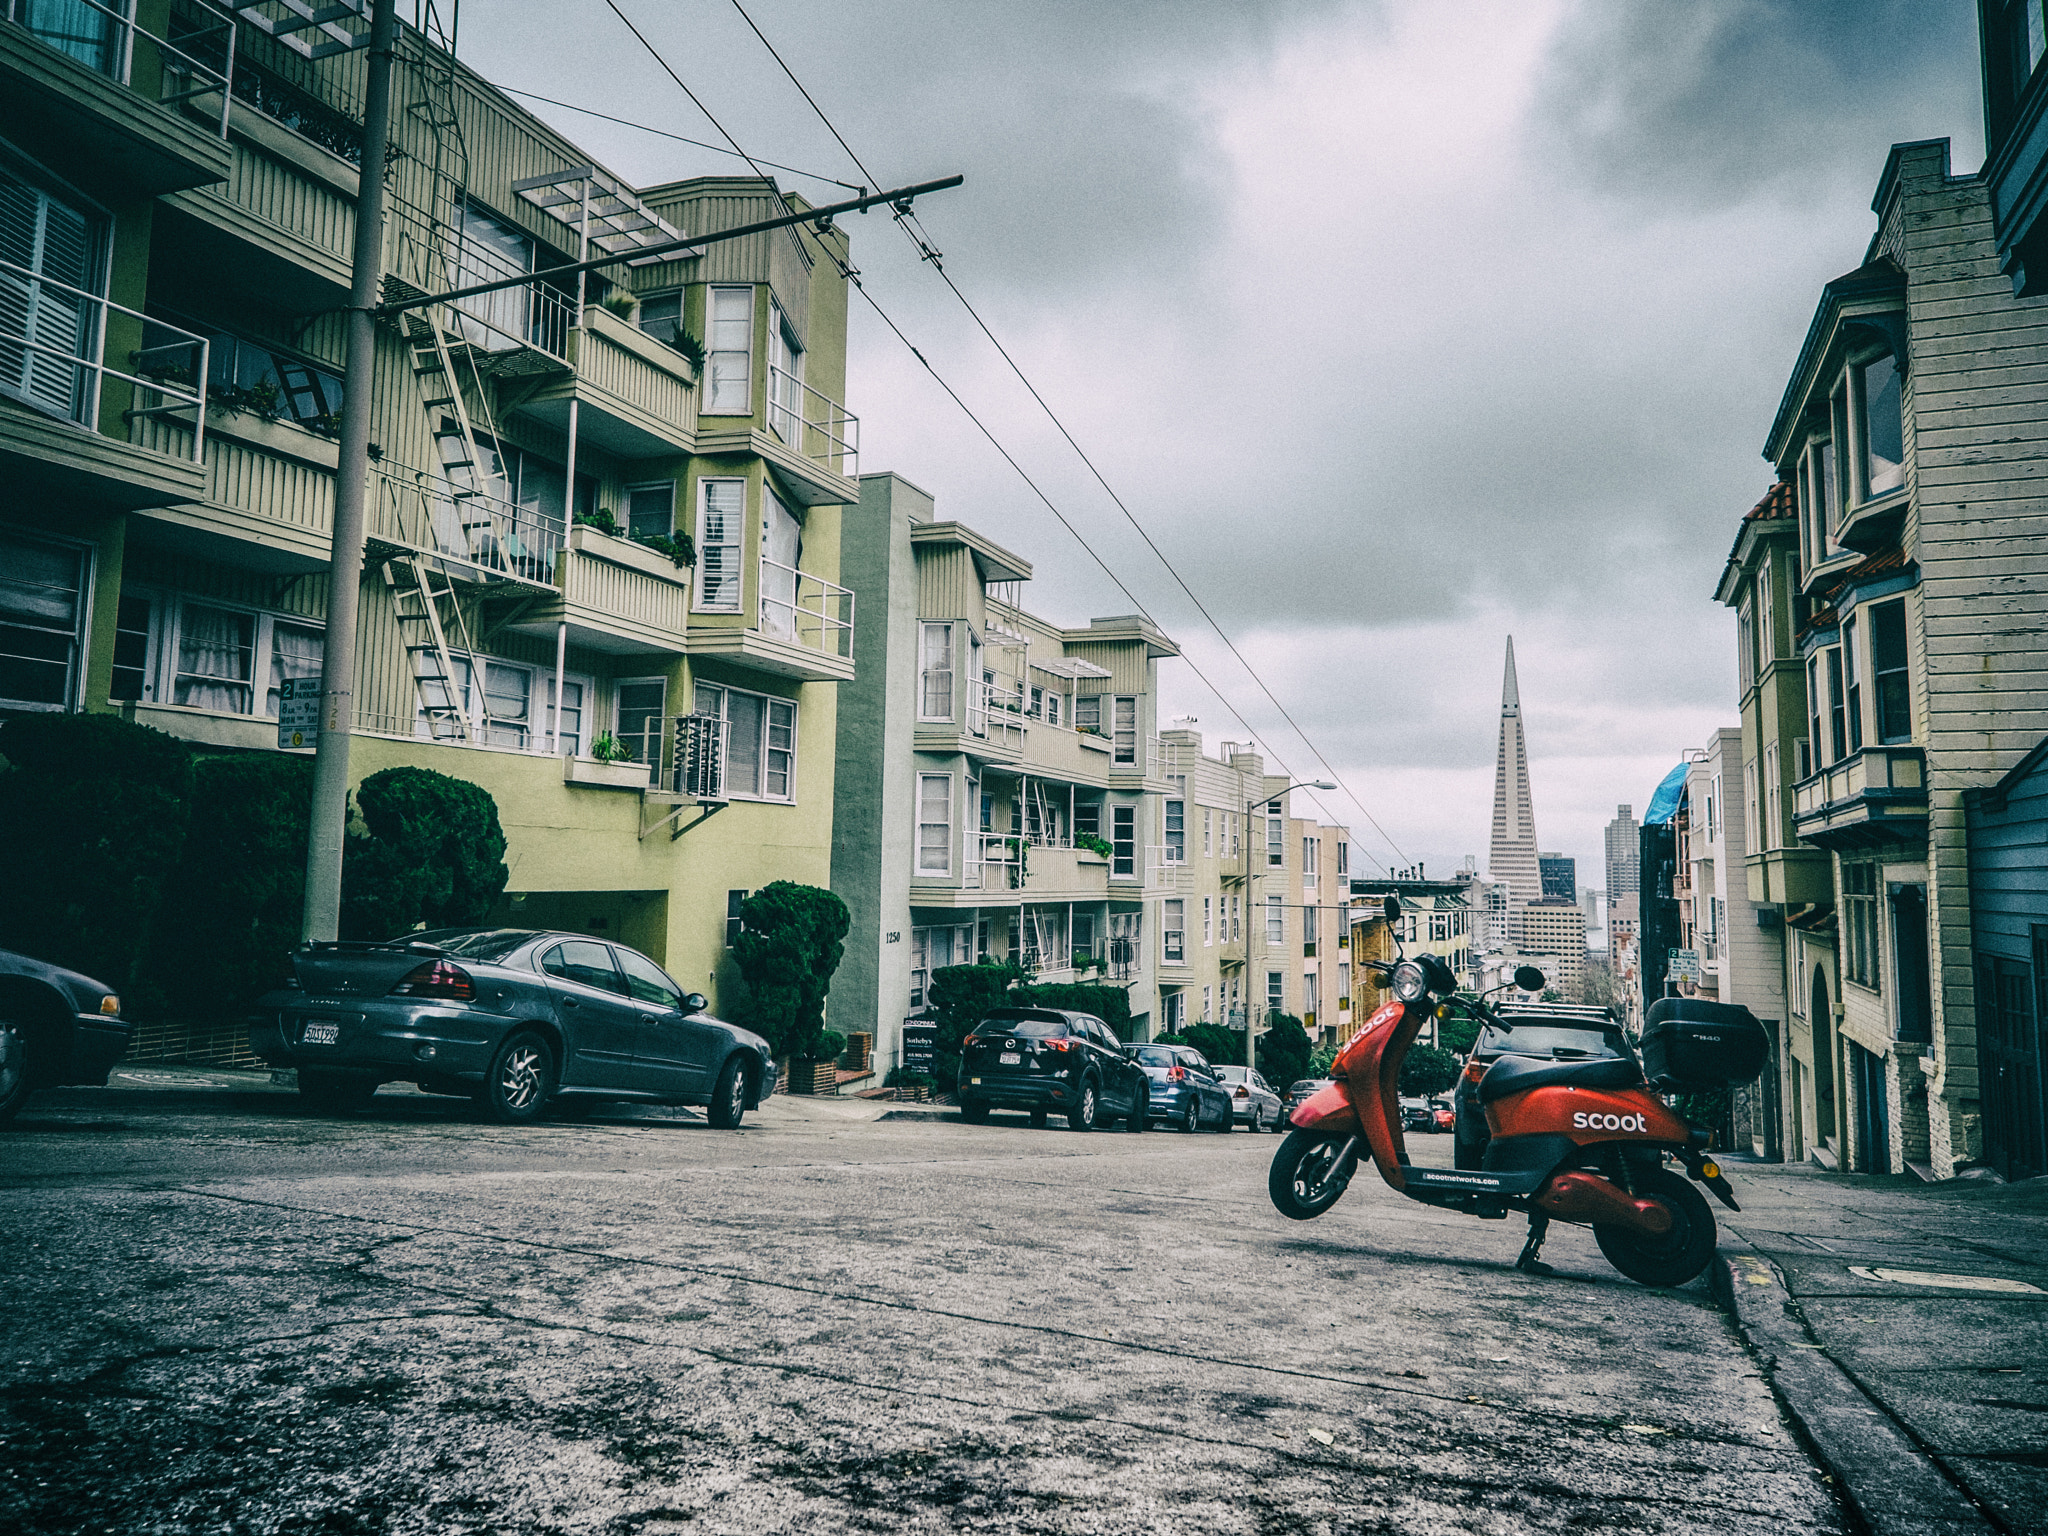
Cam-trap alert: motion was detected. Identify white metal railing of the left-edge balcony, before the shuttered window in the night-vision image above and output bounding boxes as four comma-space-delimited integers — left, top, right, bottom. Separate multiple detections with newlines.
0, 260, 207, 463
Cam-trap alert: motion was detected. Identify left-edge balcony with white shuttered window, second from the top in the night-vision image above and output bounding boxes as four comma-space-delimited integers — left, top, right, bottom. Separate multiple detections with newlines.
0, 274, 207, 510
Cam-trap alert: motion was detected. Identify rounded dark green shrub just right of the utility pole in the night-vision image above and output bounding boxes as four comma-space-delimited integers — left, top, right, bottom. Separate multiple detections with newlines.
342, 768, 510, 938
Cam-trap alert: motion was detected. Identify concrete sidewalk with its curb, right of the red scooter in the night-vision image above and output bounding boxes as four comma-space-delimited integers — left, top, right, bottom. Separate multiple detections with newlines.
1714, 1163, 2048, 1536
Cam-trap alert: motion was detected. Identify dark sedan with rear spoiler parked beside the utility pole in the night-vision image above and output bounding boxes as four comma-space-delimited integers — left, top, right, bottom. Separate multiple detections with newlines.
250, 928, 774, 1128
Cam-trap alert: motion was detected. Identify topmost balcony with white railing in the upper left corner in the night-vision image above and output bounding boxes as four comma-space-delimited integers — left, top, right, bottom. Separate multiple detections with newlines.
0, 0, 236, 195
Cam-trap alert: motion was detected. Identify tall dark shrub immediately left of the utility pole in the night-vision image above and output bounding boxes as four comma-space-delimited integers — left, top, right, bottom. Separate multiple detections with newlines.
150, 754, 313, 1018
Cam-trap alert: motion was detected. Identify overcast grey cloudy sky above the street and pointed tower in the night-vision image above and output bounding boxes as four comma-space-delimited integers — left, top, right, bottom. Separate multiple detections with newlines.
463, 0, 1982, 909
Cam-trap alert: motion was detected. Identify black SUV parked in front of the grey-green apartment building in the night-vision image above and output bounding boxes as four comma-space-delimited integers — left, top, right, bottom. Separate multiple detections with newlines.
958, 1008, 1151, 1130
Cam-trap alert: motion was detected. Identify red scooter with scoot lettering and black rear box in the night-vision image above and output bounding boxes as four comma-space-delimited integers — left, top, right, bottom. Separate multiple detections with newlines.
1268, 897, 1767, 1286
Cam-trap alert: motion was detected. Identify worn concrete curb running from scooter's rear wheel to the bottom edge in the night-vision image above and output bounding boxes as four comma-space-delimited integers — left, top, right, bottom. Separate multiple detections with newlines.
1708, 1229, 1999, 1536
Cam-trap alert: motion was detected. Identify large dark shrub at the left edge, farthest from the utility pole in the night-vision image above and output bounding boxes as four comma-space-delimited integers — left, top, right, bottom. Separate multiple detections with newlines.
0, 715, 193, 989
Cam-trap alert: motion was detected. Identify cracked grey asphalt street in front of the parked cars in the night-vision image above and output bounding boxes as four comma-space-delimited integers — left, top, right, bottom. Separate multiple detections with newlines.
0, 1071, 1845, 1536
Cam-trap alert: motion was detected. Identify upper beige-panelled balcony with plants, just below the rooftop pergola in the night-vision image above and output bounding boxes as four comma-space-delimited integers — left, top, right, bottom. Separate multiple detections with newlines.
510, 305, 696, 459
